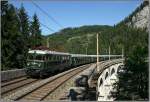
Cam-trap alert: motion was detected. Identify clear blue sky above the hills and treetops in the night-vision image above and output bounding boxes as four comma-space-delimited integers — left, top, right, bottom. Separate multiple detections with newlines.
9, 0, 142, 35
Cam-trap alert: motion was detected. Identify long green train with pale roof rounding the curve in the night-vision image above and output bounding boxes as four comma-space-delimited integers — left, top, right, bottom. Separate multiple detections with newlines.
25, 49, 122, 78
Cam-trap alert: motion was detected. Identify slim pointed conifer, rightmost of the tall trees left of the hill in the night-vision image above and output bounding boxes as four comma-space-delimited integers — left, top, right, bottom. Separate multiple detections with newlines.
30, 14, 42, 47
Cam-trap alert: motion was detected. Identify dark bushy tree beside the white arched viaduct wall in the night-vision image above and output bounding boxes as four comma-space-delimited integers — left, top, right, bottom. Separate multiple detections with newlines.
112, 45, 148, 101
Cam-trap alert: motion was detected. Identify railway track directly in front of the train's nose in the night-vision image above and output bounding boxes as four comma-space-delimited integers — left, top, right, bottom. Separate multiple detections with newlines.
1, 77, 38, 97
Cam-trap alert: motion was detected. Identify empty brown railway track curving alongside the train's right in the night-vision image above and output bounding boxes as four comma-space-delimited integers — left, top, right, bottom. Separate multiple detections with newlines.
15, 64, 91, 101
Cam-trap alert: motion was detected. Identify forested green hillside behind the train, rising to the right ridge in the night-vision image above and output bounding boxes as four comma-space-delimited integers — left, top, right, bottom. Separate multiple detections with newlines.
47, 1, 148, 54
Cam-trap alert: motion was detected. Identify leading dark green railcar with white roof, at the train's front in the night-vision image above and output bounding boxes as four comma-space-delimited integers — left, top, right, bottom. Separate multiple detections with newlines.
26, 50, 71, 77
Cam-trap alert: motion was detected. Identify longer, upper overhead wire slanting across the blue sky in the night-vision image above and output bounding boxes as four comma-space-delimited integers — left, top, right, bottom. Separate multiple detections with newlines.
31, 0, 63, 28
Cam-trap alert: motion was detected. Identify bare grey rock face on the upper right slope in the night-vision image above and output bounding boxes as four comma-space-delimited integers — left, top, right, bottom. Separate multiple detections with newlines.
127, 5, 150, 28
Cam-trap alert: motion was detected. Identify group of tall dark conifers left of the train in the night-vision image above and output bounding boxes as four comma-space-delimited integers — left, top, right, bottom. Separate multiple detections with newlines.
1, 1, 43, 70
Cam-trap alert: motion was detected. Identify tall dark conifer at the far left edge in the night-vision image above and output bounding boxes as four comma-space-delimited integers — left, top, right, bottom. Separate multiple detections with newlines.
1, 1, 22, 70
